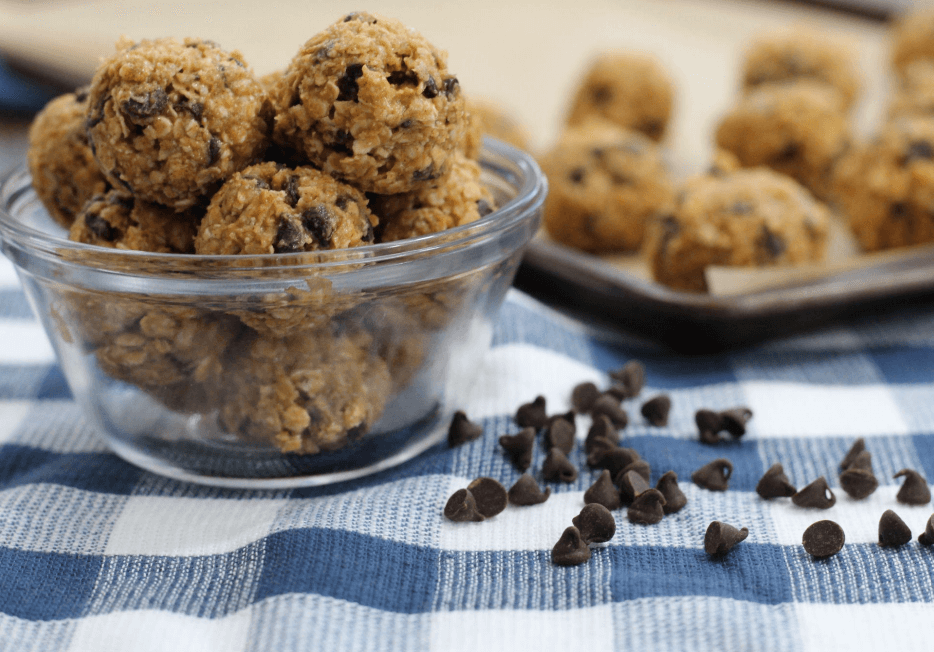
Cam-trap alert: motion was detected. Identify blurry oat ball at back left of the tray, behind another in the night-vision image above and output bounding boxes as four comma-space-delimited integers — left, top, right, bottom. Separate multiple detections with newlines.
567, 51, 674, 141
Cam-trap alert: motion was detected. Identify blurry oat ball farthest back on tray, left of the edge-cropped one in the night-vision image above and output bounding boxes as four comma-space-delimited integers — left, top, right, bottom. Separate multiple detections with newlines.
742, 28, 860, 108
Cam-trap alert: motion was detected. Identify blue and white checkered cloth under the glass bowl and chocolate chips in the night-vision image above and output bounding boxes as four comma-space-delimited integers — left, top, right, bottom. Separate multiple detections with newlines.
0, 251, 934, 652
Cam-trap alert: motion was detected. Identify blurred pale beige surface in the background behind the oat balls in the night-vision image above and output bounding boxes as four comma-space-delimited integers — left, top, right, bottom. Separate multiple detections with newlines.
0, 0, 889, 171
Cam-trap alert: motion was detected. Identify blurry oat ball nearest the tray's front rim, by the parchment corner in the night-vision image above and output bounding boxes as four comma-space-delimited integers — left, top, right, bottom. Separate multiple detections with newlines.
645, 168, 829, 292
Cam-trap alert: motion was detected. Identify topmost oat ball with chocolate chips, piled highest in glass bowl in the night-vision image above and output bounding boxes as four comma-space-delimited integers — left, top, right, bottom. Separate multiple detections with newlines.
274, 13, 467, 194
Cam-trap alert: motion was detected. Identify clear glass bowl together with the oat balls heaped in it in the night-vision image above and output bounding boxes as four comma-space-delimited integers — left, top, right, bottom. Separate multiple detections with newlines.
0, 12, 547, 488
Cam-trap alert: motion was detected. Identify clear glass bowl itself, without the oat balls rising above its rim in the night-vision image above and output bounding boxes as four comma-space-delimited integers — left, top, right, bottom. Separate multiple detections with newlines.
0, 139, 547, 488
